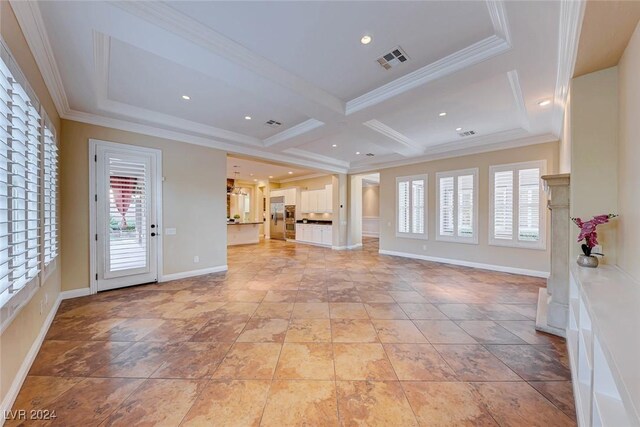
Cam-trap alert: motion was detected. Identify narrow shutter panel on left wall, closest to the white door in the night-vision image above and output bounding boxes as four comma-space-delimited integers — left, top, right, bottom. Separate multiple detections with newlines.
42, 122, 58, 266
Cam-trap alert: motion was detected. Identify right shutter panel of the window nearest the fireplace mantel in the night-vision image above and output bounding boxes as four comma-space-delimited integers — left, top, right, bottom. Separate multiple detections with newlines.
518, 168, 540, 241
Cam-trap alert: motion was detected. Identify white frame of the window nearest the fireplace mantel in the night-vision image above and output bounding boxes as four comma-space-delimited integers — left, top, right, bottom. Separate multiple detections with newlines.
488, 160, 547, 251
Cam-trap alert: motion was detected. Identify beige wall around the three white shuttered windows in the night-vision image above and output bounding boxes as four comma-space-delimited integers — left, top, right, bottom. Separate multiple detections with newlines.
380, 142, 558, 272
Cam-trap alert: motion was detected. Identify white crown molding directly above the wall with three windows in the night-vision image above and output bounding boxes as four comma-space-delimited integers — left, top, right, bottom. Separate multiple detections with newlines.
349, 129, 558, 174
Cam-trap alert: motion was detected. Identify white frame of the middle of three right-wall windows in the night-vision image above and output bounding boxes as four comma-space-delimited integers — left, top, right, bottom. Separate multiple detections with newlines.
436, 168, 480, 245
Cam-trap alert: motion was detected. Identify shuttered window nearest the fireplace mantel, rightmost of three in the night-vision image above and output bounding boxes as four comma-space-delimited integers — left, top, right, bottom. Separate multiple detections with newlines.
489, 160, 546, 249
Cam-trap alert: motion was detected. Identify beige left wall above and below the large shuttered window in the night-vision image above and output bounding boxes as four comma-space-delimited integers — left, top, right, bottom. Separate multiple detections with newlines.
0, 1, 64, 409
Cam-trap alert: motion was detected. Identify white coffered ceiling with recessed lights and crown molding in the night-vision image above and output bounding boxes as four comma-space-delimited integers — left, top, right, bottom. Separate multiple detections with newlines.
11, 1, 584, 172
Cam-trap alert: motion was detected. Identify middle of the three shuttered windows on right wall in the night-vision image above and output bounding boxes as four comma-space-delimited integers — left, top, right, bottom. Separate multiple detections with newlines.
436, 168, 478, 244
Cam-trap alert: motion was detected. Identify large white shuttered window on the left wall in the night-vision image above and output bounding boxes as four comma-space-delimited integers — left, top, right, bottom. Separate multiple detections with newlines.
0, 39, 58, 329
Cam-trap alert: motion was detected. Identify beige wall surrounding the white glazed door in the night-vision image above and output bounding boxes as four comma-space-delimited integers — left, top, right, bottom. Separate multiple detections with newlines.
61, 120, 227, 290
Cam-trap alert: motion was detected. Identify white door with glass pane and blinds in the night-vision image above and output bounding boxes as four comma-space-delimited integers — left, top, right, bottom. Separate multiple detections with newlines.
92, 141, 161, 291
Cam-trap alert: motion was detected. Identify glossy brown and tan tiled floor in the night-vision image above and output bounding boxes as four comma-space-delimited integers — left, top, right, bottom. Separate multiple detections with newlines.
7, 239, 575, 427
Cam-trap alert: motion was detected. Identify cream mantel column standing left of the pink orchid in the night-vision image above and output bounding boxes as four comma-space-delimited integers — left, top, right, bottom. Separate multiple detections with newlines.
536, 174, 571, 337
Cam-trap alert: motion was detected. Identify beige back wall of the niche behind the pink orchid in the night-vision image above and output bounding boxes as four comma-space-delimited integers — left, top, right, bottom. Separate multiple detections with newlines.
570, 67, 618, 264
